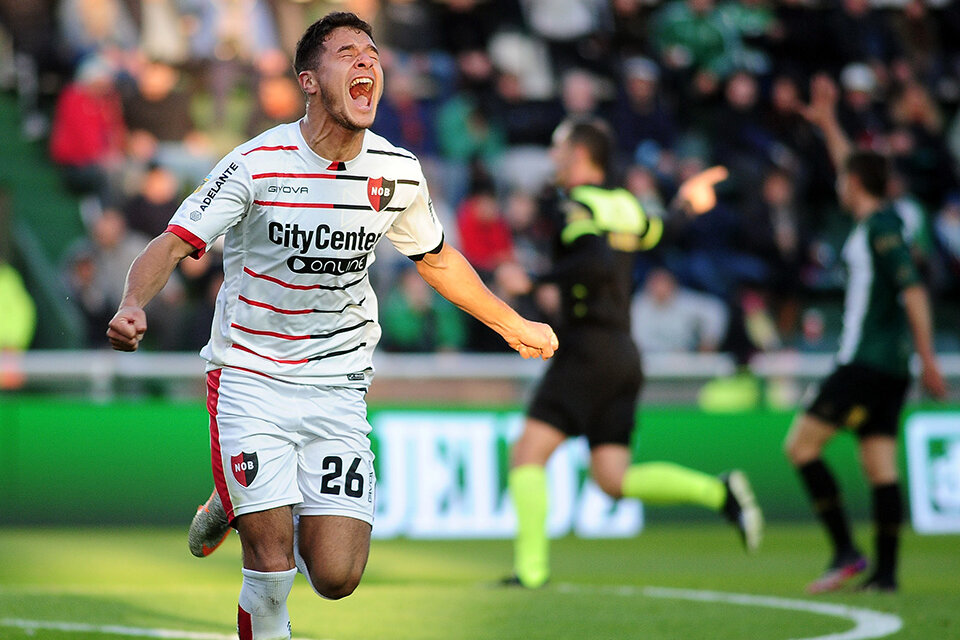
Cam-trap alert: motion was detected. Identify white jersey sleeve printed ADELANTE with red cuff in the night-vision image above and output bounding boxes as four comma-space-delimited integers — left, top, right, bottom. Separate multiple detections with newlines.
166, 151, 253, 258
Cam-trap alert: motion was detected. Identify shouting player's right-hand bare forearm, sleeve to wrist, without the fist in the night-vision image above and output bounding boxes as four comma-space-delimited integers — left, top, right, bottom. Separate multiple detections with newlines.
417, 245, 521, 335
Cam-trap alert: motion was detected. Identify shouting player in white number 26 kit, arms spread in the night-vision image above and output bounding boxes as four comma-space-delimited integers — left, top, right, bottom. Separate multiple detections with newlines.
107, 13, 557, 640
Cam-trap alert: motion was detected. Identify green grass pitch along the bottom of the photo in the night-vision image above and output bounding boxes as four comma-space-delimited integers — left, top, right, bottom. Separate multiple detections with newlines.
0, 522, 960, 640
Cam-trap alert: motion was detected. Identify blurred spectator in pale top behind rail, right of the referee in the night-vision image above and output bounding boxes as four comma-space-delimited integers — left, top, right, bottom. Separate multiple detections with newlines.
630, 268, 727, 353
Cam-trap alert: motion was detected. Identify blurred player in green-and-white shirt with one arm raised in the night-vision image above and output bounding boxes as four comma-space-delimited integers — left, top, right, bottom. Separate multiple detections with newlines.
785, 76, 946, 593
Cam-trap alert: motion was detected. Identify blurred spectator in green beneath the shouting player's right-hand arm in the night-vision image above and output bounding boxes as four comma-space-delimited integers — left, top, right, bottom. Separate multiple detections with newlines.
380, 266, 466, 353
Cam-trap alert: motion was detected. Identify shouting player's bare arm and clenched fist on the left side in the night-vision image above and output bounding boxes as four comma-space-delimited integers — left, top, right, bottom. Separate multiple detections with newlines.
107, 232, 196, 351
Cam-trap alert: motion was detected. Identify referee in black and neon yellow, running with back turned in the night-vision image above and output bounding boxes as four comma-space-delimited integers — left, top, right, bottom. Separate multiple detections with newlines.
505, 121, 763, 588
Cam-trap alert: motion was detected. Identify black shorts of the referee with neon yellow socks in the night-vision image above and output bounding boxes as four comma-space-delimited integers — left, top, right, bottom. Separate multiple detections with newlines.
527, 330, 643, 448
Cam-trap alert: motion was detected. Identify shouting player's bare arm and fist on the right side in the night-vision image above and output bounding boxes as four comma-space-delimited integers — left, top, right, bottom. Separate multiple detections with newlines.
416, 244, 558, 360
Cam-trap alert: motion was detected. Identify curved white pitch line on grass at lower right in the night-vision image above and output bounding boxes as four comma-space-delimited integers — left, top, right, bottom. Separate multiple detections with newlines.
557, 584, 903, 640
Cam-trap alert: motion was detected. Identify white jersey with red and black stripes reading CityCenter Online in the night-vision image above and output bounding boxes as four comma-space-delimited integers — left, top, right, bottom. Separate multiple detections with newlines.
167, 122, 443, 387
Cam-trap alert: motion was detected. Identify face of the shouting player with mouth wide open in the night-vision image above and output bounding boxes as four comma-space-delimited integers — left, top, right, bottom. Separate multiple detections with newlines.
317, 27, 383, 131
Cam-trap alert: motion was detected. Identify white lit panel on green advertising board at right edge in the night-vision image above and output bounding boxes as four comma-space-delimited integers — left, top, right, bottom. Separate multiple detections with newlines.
905, 413, 960, 533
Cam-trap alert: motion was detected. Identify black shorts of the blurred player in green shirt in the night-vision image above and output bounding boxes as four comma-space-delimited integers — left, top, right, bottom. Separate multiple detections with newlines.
807, 364, 910, 438
